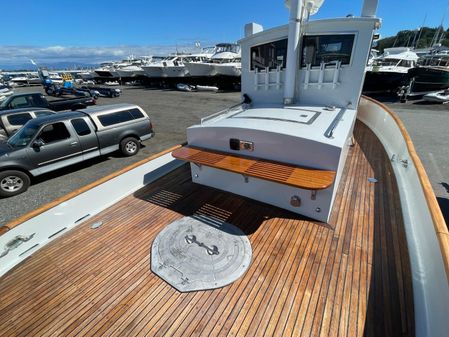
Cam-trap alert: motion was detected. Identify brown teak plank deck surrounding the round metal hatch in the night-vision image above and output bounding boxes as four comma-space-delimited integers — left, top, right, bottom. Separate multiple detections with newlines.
0, 123, 414, 336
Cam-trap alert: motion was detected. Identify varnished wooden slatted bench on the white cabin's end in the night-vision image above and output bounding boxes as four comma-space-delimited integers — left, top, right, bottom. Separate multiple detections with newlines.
172, 146, 335, 190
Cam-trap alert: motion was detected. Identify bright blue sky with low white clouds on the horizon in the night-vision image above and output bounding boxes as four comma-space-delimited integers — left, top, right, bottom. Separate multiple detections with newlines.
0, 0, 449, 68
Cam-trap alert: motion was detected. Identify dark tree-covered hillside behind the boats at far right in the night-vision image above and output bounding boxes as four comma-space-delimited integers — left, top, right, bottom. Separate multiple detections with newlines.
376, 27, 449, 52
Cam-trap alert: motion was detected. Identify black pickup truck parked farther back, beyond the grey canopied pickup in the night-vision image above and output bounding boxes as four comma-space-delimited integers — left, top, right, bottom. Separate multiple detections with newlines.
0, 92, 95, 111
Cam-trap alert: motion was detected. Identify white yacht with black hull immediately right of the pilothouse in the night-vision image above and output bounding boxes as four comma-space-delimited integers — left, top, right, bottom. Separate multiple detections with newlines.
363, 47, 418, 93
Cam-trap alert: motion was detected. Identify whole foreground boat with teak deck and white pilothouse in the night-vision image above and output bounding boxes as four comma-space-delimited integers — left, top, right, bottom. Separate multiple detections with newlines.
0, 0, 449, 337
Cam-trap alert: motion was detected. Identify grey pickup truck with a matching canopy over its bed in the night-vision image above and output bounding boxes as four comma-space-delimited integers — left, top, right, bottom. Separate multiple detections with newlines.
0, 104, 154, 197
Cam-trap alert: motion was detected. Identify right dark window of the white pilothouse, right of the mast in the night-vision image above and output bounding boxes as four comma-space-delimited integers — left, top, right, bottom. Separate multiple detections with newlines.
301, 34, 355, 67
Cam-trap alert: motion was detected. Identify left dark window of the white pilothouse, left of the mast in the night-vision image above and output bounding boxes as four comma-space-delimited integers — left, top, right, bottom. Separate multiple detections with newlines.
251, 39, 287, 70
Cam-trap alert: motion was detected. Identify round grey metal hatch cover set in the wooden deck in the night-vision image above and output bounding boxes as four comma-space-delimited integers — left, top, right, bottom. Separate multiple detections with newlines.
151, 217, 248, 292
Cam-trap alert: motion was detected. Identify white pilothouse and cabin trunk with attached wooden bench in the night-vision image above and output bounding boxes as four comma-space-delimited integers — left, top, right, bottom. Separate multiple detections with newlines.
173, 1, 380, 222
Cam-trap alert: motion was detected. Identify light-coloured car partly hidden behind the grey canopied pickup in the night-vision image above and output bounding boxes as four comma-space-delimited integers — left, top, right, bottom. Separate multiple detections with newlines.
0, 108, 55, 142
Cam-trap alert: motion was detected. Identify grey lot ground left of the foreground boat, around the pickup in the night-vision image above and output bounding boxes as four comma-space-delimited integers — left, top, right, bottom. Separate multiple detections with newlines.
0, 86, 240, 226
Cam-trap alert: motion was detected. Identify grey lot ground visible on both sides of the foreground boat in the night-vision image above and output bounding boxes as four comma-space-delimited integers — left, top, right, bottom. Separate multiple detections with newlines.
0, 87, 449, 226
